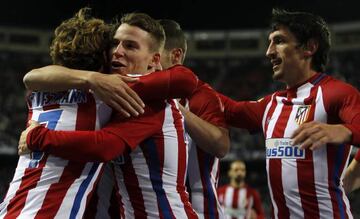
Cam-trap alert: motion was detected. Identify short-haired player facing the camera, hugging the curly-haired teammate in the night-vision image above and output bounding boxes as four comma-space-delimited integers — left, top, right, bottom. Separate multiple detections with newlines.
18, 13, 197, 218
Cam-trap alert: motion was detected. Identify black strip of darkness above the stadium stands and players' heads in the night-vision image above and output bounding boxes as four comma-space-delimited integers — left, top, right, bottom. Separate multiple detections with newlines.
0, 0, 360, 31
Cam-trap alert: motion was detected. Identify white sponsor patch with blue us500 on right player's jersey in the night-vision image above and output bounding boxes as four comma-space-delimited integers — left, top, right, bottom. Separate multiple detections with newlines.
265, 138, 305, 159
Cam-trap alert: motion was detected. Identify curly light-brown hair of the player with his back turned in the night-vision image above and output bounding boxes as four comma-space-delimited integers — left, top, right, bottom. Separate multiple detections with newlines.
50, 7, 114, 71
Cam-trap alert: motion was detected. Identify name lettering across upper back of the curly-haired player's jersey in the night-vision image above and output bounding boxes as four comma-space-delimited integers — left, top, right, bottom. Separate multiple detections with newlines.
28, 89, 87, 107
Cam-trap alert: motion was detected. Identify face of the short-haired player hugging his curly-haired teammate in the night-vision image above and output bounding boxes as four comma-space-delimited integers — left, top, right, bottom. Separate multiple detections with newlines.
111, 24, 160, 75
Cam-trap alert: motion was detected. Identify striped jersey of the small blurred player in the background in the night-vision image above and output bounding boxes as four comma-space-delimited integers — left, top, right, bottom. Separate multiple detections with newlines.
217, 185, 265, 219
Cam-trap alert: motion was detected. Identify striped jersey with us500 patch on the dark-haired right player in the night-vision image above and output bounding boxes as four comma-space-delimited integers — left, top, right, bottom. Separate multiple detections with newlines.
223, 73, 360, 219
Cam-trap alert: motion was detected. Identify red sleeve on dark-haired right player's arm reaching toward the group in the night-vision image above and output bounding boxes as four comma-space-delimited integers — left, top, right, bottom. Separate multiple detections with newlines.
219, 94, 270, 132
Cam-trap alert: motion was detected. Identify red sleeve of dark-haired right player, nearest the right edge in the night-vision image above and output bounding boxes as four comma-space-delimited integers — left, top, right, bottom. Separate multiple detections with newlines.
323, 80, 360, 146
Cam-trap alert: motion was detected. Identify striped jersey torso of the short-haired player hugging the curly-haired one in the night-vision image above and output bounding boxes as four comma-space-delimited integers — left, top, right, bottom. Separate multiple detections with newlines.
109, 100, 197, 218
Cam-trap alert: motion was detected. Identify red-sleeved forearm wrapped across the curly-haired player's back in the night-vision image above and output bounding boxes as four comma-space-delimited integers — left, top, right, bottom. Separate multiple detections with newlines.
26, 126, 127, 162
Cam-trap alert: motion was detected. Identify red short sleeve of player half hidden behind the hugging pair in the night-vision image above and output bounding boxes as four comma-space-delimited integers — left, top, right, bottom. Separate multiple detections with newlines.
189, 81, 227, 128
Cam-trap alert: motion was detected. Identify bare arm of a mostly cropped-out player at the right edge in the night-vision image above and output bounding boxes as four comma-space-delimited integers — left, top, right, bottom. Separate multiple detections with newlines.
343, 150, 360, 193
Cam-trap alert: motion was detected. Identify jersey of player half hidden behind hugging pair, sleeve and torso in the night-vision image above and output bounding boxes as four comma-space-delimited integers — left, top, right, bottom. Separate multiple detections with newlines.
187, 81, 226, 219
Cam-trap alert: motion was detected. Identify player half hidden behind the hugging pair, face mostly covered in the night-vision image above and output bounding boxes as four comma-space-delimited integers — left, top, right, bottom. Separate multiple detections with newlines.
159, 19, 230, 218
